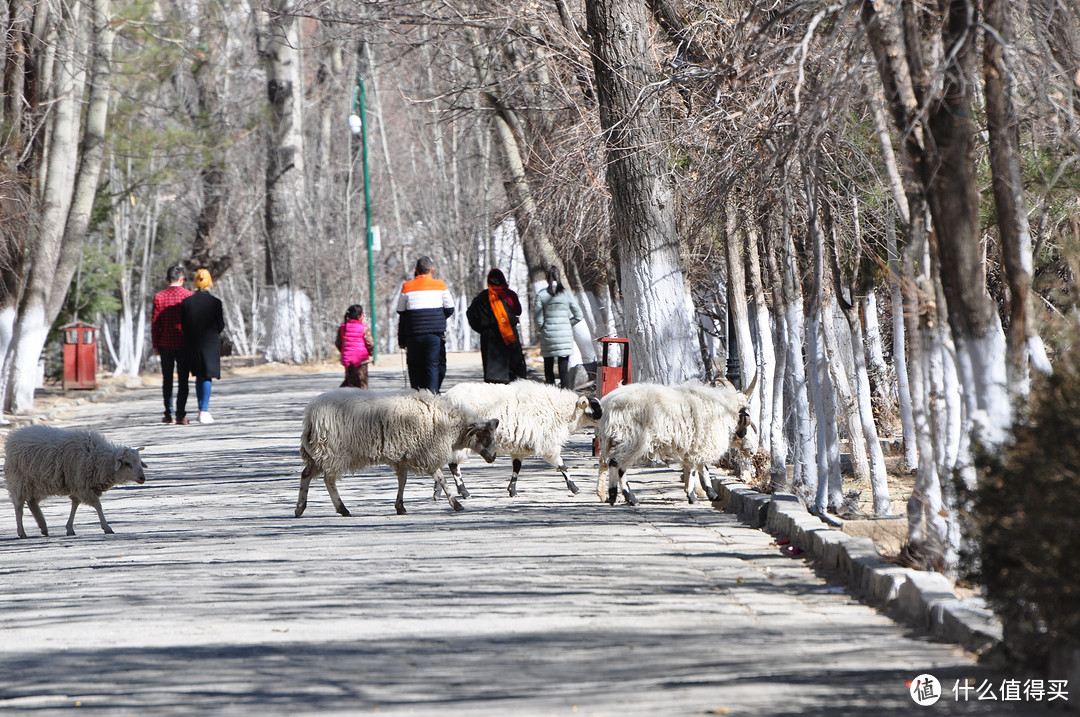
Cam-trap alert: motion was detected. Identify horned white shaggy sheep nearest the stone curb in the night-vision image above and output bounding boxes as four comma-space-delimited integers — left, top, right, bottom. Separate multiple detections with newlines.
596, 376, 757, 505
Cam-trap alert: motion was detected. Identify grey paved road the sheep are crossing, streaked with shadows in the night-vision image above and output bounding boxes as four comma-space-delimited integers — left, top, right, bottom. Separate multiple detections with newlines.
0, 357, 1049, 716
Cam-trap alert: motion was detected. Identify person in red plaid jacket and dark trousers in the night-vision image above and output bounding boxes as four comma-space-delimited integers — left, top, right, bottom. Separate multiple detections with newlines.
150, 267, 191, 424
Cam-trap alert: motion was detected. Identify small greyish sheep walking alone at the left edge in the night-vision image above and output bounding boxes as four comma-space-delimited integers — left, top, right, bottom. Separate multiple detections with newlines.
4, 425, 146, 538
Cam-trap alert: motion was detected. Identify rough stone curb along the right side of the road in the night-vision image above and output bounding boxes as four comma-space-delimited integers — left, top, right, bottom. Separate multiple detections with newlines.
713, 479, 1003, 660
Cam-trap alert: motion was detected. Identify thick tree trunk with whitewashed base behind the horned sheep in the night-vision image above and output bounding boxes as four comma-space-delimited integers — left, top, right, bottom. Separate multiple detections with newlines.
585, 0, 703, 383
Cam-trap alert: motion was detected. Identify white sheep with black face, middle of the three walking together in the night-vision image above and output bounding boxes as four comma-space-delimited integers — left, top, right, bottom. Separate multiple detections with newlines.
436, 380, 600, 498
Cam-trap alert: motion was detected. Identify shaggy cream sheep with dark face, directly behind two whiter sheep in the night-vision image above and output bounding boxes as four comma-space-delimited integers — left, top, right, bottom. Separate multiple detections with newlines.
296, 388, 499, 517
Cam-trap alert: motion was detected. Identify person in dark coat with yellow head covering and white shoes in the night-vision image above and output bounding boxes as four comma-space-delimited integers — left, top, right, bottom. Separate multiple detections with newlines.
180, 269, 225, 423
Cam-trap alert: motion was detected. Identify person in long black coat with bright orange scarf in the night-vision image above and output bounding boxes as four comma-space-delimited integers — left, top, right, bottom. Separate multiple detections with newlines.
465, 269, 526, 383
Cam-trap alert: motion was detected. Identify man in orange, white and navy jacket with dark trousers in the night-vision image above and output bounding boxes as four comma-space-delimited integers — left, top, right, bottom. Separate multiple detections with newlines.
397, 256, 454, 393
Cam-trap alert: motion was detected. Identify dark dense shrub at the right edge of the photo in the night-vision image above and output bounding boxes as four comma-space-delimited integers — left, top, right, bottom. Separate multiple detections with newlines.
971, 347, 1080, 668
